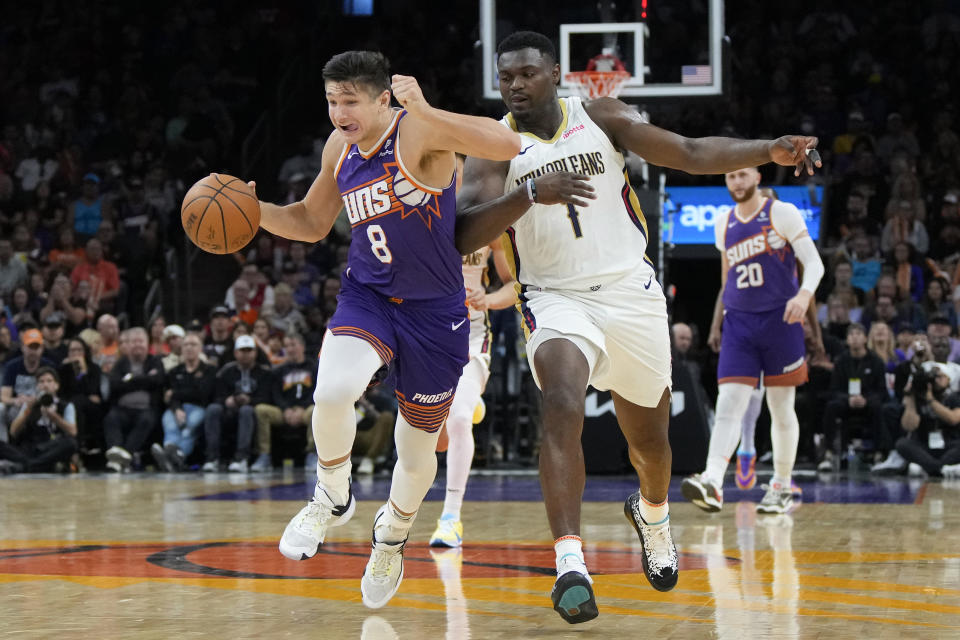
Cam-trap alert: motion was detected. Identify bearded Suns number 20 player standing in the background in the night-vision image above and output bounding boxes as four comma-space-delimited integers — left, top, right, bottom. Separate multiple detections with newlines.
683, 167, 824, 513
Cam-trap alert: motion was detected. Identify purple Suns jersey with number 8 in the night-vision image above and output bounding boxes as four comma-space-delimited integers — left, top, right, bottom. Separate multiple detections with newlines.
334, 110, 463, 300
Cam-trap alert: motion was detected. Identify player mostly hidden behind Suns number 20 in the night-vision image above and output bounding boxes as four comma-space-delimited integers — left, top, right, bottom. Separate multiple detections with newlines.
707, 187, 825, 490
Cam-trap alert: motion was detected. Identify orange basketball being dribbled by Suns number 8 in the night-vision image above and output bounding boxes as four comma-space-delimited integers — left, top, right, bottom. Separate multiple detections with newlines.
180, 173, 260, 254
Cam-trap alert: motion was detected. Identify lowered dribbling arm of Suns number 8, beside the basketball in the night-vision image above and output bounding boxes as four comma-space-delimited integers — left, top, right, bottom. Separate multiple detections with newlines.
250, 131, 346, 242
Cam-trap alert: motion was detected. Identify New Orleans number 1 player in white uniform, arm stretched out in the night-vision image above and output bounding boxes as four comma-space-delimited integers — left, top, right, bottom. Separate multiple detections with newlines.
457, 31, 816, 623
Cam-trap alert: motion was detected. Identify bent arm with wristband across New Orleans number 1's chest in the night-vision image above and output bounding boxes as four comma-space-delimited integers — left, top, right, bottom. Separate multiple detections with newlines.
456, 157, 597, 255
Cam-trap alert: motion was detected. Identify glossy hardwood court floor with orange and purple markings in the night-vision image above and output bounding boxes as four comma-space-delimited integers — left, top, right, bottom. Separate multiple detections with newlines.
0, 472, 960, 640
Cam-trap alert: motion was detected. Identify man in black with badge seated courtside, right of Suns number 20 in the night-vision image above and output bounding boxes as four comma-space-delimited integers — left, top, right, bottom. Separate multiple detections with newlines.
817, 323, 893, 471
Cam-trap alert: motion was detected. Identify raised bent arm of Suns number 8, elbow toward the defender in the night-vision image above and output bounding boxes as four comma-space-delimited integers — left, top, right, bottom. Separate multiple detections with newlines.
392, 75, 520, 160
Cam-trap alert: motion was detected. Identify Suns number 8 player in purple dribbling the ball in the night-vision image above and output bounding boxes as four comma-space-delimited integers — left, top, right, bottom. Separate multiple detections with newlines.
249, 51, 520, 608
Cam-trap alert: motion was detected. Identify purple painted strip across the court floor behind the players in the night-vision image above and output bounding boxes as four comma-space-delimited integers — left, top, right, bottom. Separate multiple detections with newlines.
194, 474, 923, 504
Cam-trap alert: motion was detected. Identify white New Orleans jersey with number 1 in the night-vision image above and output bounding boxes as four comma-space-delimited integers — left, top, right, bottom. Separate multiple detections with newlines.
502, 97, 653, 293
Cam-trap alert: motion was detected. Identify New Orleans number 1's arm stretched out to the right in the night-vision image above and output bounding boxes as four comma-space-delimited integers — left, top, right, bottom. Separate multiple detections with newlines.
586, 98, 822, 176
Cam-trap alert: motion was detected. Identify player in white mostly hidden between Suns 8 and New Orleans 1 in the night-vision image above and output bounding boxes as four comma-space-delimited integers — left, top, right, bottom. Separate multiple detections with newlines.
430, 155, 517, 547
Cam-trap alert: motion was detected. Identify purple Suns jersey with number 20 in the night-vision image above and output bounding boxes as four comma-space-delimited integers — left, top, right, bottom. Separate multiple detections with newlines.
715, 198, 807, 313
